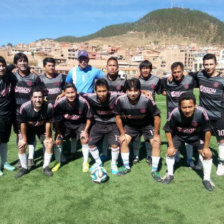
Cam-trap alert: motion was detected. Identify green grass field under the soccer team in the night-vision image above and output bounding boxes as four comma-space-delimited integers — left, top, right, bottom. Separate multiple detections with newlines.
0, 91, 224, 224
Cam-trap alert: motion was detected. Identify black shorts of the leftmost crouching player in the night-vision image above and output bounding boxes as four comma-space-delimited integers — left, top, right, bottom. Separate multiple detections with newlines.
19, 125, 46, 145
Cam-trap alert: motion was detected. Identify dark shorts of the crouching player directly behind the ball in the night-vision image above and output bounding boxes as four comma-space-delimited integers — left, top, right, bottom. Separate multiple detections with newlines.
88, 122, 120, 146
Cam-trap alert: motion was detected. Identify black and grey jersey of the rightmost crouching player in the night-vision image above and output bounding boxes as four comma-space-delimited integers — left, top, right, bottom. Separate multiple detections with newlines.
164, 106, 210, 141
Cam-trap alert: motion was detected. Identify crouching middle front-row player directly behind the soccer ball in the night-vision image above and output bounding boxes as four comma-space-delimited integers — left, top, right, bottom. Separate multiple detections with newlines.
85, 79, 120, 175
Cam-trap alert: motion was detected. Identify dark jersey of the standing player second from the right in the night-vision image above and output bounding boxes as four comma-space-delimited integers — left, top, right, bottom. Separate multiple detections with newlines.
161, 75, 195, 117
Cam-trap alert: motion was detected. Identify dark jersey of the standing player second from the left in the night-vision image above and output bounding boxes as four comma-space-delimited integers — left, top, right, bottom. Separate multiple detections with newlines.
11, 71, 41, 115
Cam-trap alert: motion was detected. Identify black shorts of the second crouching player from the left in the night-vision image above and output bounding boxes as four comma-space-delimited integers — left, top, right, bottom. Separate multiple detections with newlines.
61, 123, 86, 140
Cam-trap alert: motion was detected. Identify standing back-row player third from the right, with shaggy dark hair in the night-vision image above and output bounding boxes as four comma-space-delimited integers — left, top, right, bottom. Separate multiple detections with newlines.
133, 60, 160, 166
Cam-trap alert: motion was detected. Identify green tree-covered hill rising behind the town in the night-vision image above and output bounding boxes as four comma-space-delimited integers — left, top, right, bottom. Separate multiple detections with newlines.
56, 8, 224, 45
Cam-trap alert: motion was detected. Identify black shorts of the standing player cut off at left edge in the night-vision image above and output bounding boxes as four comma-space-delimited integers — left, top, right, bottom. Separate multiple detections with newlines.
0, 117, 12, 143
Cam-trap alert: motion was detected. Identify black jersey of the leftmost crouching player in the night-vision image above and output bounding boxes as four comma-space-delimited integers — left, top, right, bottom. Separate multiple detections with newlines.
18, 101, 54, 128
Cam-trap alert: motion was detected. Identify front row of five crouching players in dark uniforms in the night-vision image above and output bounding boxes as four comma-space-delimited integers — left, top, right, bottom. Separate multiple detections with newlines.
16, 78, 214, 190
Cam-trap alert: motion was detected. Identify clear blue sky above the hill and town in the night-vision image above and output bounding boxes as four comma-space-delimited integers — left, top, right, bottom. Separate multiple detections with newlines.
0, 0, 224, 45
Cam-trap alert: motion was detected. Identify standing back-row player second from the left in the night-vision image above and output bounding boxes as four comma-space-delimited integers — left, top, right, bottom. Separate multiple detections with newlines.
12, 53, 41, 169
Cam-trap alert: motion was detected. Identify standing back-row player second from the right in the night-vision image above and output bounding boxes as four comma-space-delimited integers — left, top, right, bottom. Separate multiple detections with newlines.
161, 62, 195, 169
